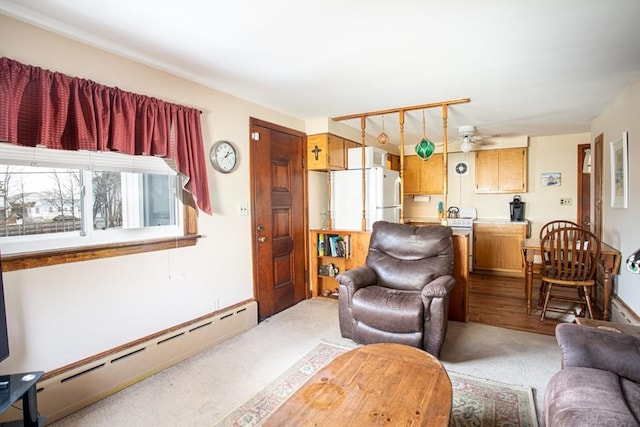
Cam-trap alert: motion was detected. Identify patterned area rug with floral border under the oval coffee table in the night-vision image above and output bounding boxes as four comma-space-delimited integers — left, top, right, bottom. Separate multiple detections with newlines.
214, 343, 538, 427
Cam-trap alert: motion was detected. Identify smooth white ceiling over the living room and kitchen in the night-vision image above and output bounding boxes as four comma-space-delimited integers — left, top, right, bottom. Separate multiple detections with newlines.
0, 0, 640, 147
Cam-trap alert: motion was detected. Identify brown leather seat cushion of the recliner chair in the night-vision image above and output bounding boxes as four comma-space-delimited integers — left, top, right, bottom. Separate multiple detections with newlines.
352, 286, 424, 335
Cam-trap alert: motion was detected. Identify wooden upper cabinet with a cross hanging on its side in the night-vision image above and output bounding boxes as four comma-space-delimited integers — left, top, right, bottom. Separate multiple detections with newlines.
307, 133, 360, 171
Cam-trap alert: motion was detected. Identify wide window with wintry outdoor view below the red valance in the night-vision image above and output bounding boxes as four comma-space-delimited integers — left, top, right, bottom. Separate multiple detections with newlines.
0, 147, 181, 253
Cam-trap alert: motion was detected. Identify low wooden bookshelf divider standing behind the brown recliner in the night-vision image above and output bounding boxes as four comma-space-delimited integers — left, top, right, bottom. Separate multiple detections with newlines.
309, 230, 469, 322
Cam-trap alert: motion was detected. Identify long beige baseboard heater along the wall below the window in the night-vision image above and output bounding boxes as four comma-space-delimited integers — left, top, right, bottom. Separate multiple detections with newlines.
15, 301, 258, 423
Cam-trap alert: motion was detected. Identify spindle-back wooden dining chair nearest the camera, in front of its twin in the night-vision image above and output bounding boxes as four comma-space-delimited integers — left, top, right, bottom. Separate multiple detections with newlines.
540, 227, 600, 321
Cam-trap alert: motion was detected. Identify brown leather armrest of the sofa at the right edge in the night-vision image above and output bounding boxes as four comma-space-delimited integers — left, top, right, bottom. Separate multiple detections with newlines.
556, 323, 640, 382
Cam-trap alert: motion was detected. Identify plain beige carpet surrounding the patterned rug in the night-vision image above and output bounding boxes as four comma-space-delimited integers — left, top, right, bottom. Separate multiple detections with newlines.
52, 298, 560, 427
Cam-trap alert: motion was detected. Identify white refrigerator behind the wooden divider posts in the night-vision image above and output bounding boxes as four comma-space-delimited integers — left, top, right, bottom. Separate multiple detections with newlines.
331, 167, 400, 231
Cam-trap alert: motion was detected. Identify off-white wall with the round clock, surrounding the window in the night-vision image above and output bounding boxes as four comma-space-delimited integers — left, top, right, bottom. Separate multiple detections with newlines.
0, 15, 305, 372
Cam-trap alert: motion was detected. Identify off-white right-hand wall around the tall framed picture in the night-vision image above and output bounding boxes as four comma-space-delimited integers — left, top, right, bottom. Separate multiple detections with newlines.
591, 78, 640, 314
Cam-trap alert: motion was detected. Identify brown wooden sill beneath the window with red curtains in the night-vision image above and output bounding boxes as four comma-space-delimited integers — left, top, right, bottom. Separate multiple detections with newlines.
2, 234, 202, 272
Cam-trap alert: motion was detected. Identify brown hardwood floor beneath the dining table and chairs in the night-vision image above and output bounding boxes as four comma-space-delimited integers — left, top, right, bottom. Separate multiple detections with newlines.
468, 273, 601, 335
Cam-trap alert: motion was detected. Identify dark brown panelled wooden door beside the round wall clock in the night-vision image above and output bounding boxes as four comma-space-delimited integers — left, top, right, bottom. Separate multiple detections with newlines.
251, 118, 308, 319
